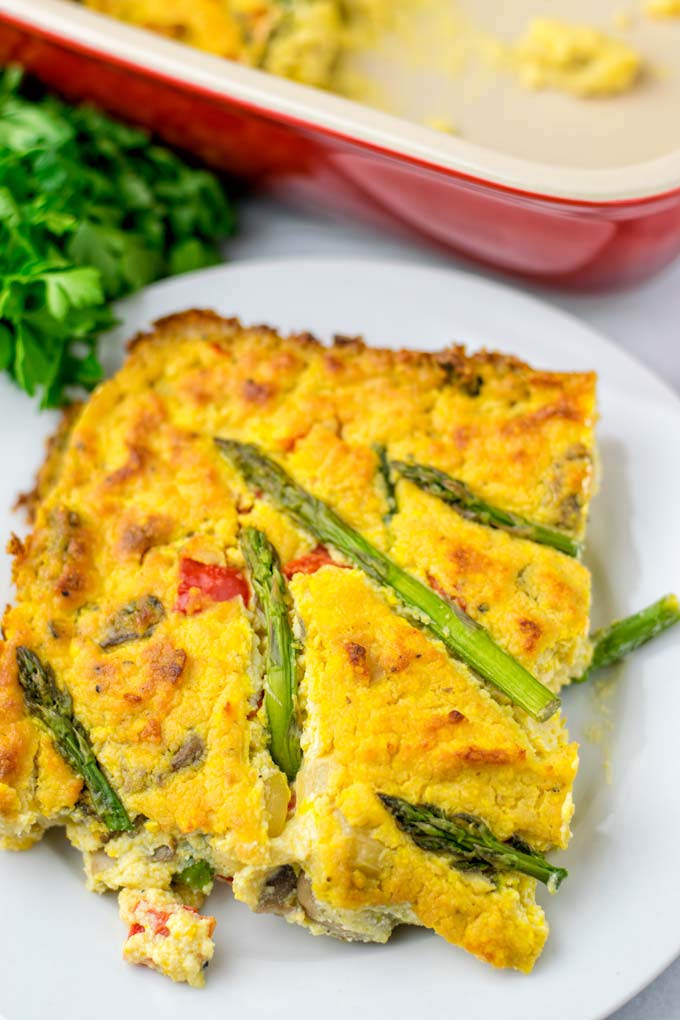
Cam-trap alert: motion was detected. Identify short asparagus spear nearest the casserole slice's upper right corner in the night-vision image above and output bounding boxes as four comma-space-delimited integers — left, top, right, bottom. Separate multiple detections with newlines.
393, 460, 581, 556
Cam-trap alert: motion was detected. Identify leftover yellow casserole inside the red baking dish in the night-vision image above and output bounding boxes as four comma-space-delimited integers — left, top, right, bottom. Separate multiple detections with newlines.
84, 0, 648, 98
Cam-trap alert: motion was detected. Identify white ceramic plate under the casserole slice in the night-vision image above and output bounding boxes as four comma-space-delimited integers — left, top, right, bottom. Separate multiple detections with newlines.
0, 259, 680, 1020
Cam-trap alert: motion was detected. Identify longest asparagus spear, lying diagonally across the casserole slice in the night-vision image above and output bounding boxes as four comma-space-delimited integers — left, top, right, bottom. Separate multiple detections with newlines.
215, 439, 560, 721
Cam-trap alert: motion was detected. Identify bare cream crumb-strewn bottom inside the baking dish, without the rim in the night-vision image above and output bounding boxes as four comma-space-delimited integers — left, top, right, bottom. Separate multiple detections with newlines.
352, 0, 680, 169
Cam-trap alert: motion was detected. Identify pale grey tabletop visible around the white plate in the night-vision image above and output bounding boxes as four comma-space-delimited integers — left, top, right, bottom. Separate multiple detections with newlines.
230, 192, 680, 1020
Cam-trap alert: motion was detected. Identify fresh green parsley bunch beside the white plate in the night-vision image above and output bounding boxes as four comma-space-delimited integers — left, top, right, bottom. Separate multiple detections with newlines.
0, 68, 233, 407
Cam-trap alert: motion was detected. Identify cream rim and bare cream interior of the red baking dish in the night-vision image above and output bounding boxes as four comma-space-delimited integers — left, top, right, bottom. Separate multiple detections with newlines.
0, 0, 680, 202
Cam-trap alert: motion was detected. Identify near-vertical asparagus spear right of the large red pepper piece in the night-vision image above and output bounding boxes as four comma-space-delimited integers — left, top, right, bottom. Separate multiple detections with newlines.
241, 527, 302, 781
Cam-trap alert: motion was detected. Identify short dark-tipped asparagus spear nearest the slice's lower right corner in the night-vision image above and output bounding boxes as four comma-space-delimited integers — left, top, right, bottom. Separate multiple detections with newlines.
378, 794, 568, 893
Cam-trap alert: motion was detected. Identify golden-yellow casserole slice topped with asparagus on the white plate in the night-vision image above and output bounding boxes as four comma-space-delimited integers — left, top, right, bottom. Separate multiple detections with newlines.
0, 311, 595, 984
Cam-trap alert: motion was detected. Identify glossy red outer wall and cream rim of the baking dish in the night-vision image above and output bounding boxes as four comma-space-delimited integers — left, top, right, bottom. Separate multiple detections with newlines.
0, 0, 680, 290
